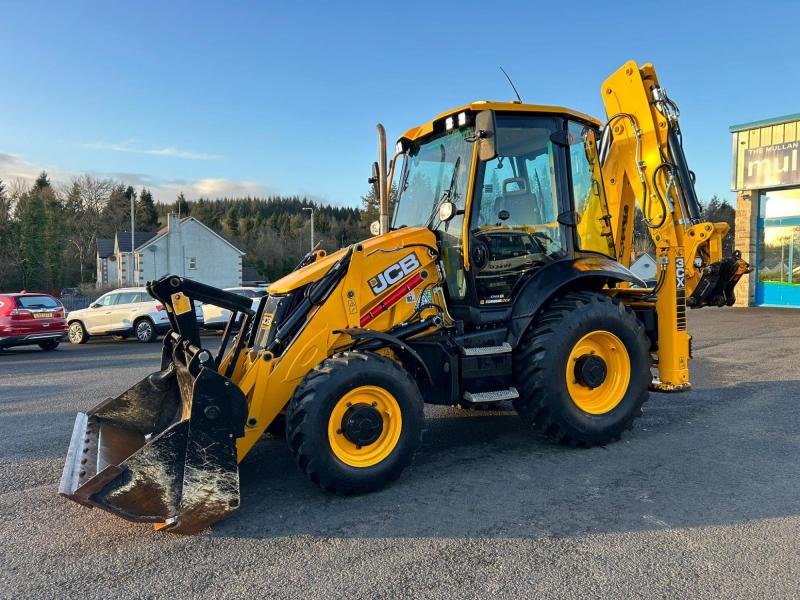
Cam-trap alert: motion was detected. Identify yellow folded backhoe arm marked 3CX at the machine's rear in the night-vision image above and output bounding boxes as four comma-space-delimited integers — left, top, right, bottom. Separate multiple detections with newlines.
600, 61, 750, 391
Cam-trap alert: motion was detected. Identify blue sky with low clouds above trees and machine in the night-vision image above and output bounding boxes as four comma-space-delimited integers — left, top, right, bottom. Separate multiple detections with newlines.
0, 0, 800, 205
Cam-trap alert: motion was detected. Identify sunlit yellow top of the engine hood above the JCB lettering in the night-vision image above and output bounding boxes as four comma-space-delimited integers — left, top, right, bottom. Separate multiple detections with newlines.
267, 227, 436, 294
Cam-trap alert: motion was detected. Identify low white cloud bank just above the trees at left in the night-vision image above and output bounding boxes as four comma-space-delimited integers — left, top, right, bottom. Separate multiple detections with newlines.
0, 152, 270, 203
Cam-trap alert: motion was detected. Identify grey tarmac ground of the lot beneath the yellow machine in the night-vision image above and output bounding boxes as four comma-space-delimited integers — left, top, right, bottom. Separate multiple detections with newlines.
0, 308, 800, 599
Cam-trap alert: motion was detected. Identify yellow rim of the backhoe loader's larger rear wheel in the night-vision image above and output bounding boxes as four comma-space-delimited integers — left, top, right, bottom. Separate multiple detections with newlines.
566, 330, 631, 415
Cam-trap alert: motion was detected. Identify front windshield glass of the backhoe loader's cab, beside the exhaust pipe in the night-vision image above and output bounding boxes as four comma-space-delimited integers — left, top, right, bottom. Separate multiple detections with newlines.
393, 127, 473, 229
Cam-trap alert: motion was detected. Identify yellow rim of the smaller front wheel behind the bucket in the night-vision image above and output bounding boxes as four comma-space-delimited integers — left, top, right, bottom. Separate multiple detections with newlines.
328, 385, 403, 468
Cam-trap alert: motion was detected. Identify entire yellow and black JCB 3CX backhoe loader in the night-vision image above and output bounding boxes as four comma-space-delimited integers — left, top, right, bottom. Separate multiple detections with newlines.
60, 62, 749, 533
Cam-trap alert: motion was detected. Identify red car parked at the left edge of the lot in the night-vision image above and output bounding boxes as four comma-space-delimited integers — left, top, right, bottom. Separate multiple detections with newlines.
0, 292, 67, 350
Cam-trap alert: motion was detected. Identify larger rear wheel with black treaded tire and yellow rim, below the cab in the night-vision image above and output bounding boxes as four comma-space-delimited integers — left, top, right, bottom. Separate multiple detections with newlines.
514, 292, 652, 447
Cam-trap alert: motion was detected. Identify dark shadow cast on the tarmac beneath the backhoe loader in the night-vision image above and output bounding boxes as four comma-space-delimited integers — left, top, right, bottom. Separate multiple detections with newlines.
211, 381, 800, 538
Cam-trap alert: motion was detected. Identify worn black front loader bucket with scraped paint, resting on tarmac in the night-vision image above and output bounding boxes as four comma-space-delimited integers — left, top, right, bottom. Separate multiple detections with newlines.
59, 333, 247, 534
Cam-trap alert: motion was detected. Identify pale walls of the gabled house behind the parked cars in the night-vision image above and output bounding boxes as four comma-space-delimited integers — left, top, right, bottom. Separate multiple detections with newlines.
97, 214, 244, 288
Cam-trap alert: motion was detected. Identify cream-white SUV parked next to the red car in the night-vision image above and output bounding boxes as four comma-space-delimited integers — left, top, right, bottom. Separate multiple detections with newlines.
67, 287, 203, 344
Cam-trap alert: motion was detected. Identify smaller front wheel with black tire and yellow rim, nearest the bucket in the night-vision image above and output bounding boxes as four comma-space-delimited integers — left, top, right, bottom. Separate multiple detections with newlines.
286, 352, 424, 494
